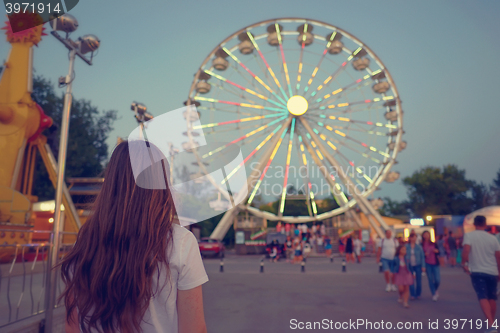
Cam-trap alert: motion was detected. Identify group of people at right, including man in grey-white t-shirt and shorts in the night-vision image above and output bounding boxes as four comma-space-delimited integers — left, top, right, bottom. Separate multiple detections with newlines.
377, 216, 500, 332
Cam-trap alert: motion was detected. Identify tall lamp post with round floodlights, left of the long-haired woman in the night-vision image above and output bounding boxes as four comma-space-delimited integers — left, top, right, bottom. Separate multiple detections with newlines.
45, 14, 100, 332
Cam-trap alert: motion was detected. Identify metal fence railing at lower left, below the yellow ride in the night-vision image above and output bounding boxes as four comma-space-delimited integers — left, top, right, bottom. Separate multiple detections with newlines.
0, 229, 76, 331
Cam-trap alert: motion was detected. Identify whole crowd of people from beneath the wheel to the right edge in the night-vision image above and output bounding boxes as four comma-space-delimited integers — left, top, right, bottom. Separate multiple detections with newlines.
268, 216, 500, 332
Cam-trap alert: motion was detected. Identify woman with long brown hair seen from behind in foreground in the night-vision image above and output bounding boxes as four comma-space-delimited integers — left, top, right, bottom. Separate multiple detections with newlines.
61, 141, 208, 333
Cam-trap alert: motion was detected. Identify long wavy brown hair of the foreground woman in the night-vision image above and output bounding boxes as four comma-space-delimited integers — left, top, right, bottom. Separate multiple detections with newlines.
61, 141, 175, 333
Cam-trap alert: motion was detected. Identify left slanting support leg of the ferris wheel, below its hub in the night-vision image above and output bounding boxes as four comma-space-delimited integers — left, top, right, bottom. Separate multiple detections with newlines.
210, 116, 293, 239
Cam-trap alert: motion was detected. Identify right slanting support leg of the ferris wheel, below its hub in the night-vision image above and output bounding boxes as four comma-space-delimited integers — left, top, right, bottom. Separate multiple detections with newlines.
300, 117, 389, 237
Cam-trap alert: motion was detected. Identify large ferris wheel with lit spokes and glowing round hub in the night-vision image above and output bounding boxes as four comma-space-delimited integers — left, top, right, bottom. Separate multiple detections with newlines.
185, 18, 406, 238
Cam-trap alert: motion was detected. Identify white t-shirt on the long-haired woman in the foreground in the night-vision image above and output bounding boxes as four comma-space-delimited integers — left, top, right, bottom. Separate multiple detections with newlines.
141, 224, 208, 333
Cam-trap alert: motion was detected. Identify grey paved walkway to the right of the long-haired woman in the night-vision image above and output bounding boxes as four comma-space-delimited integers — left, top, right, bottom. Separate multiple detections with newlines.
203, 256, 492, 332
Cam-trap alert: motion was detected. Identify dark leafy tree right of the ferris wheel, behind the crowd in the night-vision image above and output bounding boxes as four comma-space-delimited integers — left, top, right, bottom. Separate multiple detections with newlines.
403, 165, 481, 216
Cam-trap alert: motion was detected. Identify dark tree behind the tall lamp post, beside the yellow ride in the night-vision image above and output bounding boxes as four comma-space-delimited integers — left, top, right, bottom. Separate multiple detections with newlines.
31, 76, 117, 200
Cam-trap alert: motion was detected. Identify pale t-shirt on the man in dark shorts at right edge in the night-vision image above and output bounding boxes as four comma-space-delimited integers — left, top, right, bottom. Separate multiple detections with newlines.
464, 230, 500, 275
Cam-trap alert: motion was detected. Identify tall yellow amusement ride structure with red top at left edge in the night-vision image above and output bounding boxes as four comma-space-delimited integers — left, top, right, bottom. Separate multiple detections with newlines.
0, 13, 80, 261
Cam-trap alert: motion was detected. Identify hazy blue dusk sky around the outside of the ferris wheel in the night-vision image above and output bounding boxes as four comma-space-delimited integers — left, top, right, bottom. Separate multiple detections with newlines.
0, 0, 500, 199
